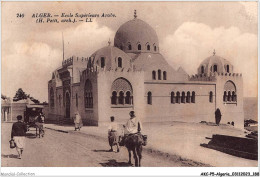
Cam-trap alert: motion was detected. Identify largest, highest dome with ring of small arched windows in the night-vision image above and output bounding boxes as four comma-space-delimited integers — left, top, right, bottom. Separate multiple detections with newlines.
114, 18, 159, 53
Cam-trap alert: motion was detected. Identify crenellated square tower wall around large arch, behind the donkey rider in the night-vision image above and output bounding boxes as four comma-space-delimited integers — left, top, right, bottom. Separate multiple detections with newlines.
97, 70, 145, 124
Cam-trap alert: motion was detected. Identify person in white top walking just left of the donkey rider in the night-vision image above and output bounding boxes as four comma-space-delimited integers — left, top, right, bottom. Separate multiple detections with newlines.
108, 116, 119, 152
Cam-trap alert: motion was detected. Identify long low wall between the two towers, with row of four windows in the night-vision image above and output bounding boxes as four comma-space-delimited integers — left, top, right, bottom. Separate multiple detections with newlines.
144, 82, 216, 122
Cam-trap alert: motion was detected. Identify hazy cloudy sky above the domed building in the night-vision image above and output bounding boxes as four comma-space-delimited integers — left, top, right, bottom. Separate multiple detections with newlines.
1, 2, 258, 101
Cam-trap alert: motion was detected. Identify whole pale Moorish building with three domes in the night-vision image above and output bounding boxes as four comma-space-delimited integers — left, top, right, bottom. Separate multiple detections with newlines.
48, 11, 244, 128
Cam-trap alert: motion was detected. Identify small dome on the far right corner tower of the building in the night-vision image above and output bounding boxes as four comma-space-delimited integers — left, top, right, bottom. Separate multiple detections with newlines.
198, 53, 233, 74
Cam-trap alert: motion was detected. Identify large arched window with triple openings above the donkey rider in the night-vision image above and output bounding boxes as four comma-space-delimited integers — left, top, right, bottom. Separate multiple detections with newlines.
111, 77, 133, 106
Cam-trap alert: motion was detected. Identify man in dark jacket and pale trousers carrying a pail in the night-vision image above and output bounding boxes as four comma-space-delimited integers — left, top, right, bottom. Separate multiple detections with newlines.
11, 115, 27, 159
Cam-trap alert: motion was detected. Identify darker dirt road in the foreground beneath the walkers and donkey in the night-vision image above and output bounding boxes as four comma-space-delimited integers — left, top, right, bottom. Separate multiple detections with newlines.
1, 123, 207, 167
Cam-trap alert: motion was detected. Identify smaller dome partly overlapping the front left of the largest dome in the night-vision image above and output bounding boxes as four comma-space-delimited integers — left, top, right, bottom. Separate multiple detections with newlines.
91, 46, 131, 69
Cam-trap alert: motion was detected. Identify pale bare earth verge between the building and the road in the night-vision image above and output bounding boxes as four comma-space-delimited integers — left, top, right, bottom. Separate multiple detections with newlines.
42, 122, 258, 167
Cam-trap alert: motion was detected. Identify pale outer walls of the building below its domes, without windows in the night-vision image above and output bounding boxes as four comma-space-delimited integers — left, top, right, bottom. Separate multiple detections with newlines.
48, 69, 244, 128
